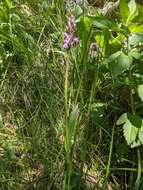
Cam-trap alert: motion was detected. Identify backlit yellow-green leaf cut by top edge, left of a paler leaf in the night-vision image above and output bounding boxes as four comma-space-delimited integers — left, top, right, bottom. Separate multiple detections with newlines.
119, 0, 129, 22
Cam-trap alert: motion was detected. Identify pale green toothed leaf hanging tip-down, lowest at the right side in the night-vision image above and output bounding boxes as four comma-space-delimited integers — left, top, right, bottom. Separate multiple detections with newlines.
123, 120, 139, 145
